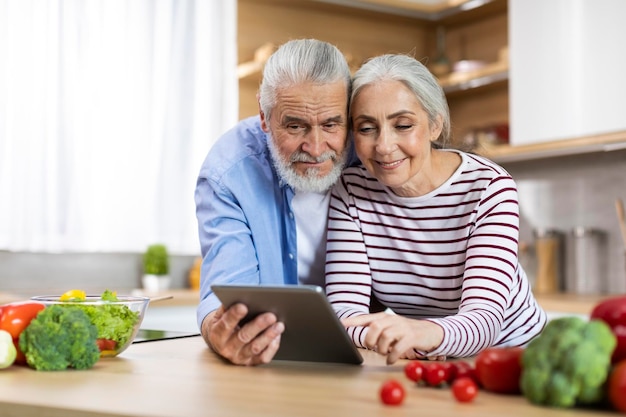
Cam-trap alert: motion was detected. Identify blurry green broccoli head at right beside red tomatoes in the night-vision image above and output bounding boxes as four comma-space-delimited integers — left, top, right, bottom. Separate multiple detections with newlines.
520, 316, 617, 407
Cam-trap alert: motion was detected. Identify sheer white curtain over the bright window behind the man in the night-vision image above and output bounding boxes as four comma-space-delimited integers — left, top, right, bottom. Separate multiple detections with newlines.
0, 0, 238, 254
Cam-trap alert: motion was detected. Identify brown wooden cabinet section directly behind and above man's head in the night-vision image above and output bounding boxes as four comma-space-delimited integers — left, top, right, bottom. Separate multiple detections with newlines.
237, 0, 427, 118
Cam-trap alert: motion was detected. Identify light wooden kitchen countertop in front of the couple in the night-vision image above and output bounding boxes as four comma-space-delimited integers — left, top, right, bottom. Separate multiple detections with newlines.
0, 337, 616, 417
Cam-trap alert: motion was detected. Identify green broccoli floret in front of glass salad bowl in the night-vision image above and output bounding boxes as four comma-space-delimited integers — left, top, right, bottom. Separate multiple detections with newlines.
19, 305, 100, 371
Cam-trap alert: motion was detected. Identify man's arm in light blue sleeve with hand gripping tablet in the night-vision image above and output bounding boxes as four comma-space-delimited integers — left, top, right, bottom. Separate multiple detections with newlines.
196, 161, 284, 365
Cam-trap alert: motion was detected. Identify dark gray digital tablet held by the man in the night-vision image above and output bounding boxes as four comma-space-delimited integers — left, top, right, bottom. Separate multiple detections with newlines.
211, 285, 363, 365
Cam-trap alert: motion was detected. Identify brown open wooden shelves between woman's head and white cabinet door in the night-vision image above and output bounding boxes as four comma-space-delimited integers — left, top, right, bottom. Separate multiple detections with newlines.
416, 1, 509, 149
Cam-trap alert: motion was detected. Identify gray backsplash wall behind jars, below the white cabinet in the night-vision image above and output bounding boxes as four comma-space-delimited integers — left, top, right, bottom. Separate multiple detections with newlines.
502, 150, 626, 293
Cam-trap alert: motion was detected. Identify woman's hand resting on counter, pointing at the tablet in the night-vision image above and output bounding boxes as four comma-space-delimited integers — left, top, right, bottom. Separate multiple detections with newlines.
341, 312, 443, 364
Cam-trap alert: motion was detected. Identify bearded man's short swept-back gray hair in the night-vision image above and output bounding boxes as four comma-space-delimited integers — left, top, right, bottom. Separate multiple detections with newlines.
259, 39, 351, 120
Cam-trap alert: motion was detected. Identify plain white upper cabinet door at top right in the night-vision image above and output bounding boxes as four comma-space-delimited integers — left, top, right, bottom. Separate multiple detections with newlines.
509, 0, 626, 145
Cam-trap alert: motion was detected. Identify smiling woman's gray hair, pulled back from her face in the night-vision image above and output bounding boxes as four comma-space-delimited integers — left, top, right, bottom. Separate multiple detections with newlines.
350, 54, 450, 148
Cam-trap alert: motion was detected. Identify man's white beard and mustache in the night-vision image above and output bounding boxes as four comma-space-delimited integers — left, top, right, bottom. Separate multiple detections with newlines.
267, 133, 348, 193
